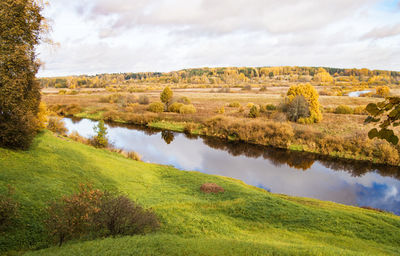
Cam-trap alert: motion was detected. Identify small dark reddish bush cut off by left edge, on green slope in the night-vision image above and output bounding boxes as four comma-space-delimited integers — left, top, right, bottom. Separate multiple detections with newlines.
0, 186, 18, 231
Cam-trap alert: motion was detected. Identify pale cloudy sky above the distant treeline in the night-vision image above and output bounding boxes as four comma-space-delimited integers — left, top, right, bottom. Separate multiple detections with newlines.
37, 0, 400, 77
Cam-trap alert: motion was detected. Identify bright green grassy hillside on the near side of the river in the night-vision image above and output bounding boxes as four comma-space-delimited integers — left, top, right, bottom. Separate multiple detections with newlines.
0, 132, 400, 255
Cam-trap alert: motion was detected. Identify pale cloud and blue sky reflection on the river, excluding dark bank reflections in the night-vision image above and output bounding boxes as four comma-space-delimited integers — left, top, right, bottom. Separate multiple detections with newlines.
66, 119, 400, 214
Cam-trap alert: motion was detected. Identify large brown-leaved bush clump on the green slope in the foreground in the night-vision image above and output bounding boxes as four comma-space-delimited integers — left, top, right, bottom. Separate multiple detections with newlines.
45, 185, 160, 246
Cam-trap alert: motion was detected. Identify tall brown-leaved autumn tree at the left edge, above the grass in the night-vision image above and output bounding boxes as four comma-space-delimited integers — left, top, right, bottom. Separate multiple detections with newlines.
0, 0, 44, 149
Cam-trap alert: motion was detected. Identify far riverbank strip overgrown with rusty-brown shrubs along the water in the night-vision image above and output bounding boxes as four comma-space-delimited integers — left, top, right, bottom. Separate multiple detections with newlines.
69, 107, 400, 166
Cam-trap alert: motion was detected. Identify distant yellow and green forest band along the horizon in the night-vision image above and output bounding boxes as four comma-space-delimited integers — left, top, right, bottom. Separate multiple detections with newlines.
40, 66, 400, 89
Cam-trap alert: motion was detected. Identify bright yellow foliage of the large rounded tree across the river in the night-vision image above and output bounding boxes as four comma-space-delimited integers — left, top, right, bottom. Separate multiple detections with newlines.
287, 83, 322, 123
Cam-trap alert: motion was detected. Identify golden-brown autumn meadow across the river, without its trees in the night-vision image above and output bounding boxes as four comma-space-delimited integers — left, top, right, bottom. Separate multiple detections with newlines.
43, 84, 400, 165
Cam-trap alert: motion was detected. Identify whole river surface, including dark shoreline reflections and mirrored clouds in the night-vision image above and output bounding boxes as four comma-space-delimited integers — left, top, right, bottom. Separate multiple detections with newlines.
64, 118, 400, 215
